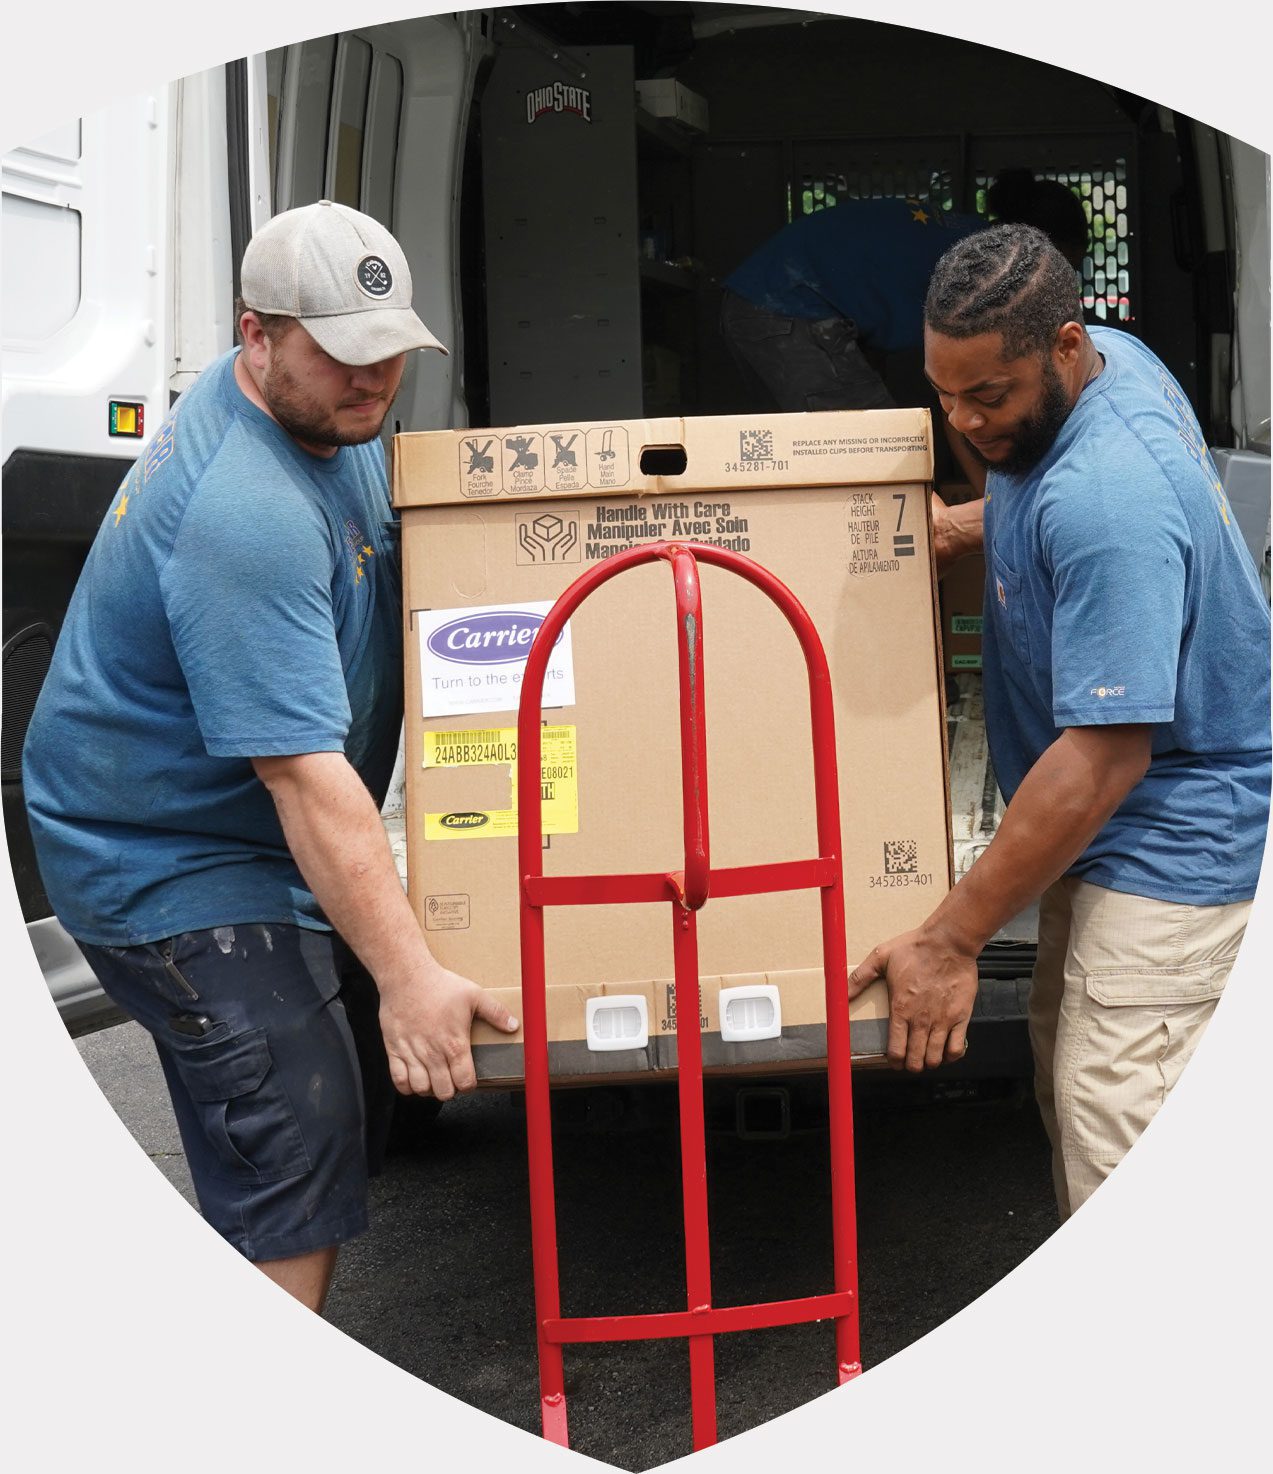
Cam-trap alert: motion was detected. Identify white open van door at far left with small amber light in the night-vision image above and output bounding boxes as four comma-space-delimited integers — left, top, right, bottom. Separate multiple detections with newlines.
0, 98, 174, 1026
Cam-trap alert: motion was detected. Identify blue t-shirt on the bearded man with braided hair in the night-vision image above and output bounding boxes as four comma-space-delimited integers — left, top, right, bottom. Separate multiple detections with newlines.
983, 327, 1270, 905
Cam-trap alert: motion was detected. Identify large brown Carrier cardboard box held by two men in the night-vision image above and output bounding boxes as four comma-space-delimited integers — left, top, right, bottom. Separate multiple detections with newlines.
393, 410, 950, 1082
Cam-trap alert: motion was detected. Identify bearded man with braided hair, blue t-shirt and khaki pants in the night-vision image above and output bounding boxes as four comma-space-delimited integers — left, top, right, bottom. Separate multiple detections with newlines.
850, 226, 1270, 1218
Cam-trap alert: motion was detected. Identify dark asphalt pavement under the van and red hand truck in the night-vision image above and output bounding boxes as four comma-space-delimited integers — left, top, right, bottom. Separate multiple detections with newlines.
78, 1024, 1056, 1470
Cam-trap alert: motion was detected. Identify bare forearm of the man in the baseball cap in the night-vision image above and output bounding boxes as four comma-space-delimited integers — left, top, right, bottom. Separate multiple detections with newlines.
258, 753, 436, 993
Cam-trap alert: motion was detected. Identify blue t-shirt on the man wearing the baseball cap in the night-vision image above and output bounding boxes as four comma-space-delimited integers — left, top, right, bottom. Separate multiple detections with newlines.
24, 352, 402, 946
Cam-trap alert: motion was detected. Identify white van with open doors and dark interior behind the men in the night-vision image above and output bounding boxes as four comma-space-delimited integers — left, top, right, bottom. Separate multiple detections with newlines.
3, 4, 1270, 1049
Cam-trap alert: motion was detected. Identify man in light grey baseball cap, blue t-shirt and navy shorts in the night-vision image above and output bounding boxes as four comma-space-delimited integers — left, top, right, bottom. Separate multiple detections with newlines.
24, 200, 517, 1310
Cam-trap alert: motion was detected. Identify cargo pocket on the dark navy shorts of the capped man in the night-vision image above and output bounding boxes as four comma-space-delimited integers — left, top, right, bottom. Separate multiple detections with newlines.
169, 1029, 309, 1182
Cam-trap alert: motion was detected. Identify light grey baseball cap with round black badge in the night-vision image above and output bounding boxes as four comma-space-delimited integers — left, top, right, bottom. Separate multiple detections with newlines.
240, 199, 446, 366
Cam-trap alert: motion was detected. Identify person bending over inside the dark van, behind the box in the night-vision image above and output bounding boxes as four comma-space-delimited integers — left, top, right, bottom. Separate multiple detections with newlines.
720, 168, 1087, 489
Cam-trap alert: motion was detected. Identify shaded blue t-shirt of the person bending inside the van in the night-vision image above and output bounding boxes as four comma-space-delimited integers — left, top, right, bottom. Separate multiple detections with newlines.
723, 199, 986, 352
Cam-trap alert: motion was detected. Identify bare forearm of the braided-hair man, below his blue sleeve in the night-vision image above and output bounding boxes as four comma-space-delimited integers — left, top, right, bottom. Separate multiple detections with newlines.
922, 728, 1149, 957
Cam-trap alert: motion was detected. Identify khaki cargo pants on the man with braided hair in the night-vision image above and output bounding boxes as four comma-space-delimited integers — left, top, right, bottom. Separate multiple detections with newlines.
1030, 877, 1251, 1219
